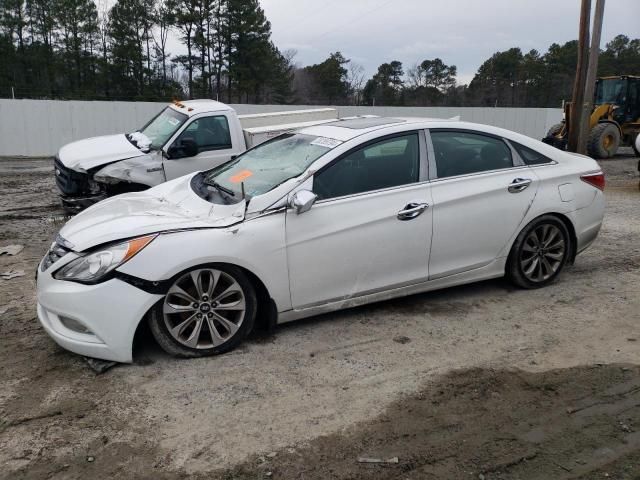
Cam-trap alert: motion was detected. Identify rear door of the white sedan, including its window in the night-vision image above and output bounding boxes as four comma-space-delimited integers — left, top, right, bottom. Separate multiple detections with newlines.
427, 129, 538, 279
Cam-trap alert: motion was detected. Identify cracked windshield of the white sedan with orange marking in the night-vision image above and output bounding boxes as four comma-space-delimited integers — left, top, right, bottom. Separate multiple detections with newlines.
204, 133, 342, 197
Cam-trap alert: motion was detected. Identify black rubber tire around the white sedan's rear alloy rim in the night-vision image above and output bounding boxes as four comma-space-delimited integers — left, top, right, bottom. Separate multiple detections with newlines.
506, 215, 573, 289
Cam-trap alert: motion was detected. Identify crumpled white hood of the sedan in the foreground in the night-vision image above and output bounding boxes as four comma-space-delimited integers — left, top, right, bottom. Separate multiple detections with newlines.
60, 175, 246, 252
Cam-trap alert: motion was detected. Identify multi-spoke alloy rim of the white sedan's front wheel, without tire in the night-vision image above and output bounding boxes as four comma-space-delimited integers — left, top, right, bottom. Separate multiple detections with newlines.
162, 268, 246, 349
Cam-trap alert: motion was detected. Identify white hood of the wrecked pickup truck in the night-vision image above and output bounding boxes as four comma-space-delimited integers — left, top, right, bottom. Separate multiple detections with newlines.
58, 133, 145, 172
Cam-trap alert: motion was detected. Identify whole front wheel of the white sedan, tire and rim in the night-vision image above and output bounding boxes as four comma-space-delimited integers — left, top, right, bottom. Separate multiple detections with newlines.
149, 265, 257, 357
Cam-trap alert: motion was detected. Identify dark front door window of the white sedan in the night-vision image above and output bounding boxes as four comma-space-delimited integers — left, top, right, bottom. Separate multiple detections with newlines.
313, 133, 420, 199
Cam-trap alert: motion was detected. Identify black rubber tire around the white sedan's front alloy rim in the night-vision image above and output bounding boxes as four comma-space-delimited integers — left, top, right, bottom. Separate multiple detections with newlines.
148, 264, 258, 358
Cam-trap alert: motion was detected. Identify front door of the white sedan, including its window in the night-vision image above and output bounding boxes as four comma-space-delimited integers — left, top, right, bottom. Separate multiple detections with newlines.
286, 133, 431, 309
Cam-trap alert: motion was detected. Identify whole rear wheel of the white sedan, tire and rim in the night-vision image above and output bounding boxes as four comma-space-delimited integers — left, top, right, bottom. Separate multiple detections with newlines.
507, 215, 572, 288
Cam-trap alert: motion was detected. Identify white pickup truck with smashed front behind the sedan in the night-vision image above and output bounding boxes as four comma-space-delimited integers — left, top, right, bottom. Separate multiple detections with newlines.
54, 100, 337, 212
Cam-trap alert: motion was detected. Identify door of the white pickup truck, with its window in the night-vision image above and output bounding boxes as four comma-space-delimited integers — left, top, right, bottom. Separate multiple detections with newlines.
164, 115, 237, 180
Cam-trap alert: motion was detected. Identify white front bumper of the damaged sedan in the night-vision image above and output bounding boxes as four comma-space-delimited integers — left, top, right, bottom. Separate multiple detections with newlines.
37, 266, 162, 363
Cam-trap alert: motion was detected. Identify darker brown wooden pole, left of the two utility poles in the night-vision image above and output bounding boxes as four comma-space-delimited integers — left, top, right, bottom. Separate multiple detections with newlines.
567, 0, 591, 152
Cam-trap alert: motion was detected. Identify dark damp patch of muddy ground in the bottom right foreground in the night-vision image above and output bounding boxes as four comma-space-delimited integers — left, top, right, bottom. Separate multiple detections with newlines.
219, 365, 640, 480
